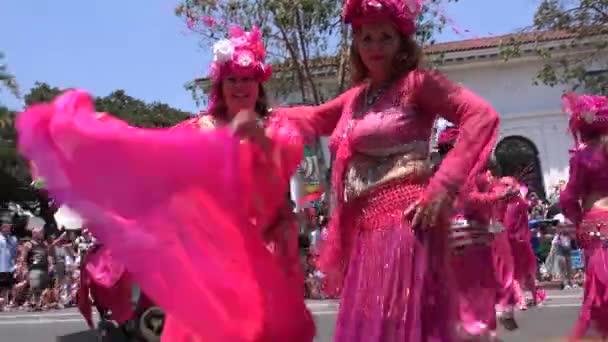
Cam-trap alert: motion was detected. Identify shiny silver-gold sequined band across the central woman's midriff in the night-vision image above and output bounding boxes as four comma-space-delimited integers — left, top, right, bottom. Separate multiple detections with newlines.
344, 151, 432, 202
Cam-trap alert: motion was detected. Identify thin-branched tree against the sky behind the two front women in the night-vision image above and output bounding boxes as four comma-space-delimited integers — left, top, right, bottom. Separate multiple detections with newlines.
175, 0, 458, 104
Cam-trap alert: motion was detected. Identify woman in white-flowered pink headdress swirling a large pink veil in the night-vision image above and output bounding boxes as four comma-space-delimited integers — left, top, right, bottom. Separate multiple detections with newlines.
17, 28, 315, 342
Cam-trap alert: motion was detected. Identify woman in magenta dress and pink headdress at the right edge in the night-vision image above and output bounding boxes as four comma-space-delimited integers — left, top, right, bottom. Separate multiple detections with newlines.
560, 94, 608, 340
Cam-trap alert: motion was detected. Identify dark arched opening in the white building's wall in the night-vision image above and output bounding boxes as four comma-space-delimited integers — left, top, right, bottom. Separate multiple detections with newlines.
494, 136, 545, 198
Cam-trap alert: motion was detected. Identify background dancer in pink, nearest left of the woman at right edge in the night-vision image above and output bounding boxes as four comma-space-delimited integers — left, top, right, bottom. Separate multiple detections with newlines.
504, 178, 545, 310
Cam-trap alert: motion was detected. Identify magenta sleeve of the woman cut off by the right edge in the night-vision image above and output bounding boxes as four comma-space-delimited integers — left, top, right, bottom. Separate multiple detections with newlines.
559, 154, 585, 224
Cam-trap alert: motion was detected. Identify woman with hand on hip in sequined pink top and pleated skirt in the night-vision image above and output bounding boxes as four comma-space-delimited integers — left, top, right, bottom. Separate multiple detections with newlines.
286, 0, 499, 342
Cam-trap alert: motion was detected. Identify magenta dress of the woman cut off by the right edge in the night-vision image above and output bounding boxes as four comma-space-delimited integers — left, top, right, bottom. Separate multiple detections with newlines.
560, 146, 608, 340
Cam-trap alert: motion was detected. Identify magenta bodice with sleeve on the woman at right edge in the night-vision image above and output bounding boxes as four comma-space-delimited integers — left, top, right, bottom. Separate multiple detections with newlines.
560, 146, 608, 223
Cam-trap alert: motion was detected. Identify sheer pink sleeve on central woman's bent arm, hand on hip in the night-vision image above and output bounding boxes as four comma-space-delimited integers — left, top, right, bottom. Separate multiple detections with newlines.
413, 70, 499, 200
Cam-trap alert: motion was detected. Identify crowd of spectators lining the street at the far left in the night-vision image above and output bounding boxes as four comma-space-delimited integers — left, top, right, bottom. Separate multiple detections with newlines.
0, 212, 93, 311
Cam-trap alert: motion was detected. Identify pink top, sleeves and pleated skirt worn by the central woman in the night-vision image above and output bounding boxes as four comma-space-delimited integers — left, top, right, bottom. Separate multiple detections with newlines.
286, 70, 499, 341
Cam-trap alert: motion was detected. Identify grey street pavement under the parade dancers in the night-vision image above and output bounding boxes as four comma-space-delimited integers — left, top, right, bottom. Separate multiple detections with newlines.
0, 290, 582, 342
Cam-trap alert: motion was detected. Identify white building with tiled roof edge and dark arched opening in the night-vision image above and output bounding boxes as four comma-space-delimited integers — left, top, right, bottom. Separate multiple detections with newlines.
276, 33, 608, 200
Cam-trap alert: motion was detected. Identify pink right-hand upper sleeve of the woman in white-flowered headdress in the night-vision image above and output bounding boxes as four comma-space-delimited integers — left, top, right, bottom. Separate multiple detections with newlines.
268, 114, 304, 181
